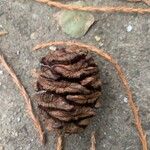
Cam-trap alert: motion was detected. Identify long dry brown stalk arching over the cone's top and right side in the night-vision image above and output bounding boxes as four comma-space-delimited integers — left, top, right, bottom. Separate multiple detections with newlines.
33, 41, 148, 150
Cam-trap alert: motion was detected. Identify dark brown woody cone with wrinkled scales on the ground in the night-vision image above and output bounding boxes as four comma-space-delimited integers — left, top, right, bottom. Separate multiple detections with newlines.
36, 47, 101, 133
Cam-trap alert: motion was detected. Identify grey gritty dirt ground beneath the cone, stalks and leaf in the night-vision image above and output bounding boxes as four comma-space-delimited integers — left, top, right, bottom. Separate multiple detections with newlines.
0, 0, 150, 150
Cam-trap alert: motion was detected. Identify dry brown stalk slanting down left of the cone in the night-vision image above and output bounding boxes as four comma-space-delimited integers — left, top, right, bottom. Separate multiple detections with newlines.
0, 54, 45, 143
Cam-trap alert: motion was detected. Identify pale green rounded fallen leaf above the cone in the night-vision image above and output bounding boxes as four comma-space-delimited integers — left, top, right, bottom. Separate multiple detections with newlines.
55, 1, 94, 38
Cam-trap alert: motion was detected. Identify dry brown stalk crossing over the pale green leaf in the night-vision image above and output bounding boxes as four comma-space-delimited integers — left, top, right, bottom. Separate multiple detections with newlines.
35, 0, 150, 14
